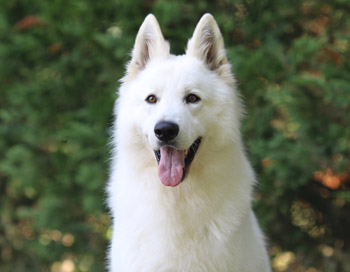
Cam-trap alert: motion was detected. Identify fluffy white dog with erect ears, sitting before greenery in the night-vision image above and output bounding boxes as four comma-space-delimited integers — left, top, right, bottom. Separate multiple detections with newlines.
108, 14, 270, 272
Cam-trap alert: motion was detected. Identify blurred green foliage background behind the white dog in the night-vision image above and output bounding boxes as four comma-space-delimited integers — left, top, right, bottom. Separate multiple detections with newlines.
0, 0, 350, 272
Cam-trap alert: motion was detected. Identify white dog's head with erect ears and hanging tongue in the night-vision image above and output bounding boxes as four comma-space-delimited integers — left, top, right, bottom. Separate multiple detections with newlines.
117, 14, 241, 186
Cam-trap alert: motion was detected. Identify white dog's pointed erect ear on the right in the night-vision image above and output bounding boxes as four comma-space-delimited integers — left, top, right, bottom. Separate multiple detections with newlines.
186, 13, 230, 74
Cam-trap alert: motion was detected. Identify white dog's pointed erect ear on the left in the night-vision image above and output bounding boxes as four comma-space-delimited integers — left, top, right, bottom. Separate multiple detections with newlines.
128, 14, 170, 75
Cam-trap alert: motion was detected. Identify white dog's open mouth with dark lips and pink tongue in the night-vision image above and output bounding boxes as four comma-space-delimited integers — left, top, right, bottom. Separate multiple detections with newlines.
154, 137, 202, 187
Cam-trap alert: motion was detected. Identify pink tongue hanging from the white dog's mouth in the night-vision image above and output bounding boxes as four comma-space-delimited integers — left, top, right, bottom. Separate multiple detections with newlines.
158, 146, 185, 187
